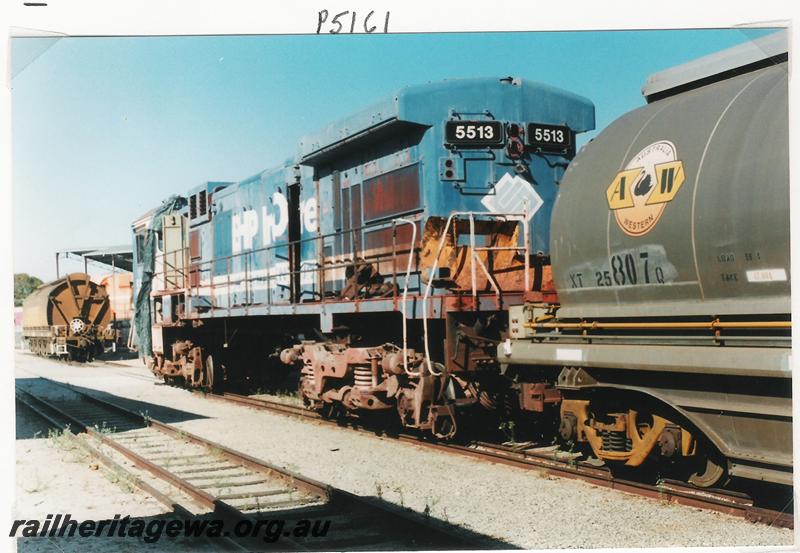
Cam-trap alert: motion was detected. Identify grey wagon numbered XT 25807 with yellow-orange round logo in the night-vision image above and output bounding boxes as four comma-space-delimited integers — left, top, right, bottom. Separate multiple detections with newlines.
498, 35, 792, 485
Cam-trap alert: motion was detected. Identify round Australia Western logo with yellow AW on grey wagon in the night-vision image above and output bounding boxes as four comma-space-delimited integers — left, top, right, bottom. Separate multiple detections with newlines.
606, 140, 686, 236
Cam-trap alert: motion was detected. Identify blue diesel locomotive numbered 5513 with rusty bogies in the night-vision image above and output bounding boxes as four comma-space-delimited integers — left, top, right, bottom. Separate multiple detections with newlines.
133, 77, 594, 437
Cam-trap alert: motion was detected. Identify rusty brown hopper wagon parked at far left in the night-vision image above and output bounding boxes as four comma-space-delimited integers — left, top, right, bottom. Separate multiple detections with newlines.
22, 273, 115, 361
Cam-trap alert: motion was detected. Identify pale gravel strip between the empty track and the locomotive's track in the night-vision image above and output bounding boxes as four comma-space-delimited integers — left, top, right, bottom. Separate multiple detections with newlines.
16, 354, 794, 549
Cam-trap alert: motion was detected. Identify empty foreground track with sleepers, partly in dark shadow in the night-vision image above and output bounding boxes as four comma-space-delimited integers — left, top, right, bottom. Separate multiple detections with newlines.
17, 378, 490, 551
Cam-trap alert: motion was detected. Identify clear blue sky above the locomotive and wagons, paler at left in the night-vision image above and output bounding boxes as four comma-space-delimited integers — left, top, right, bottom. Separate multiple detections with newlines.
12, 29, 770, 280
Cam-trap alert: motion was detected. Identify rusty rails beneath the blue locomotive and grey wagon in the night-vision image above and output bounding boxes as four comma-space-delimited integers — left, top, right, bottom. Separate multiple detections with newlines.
207, 392, 794, 528
